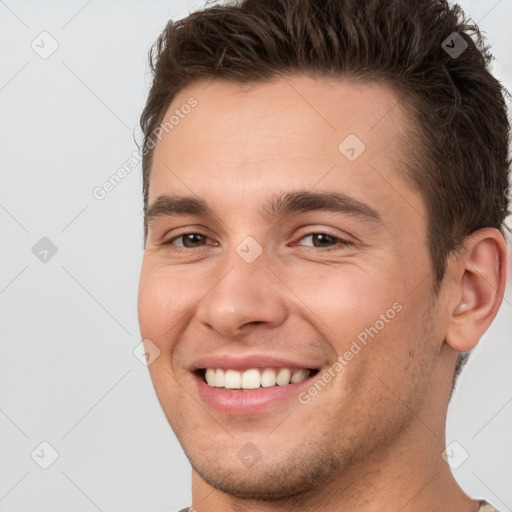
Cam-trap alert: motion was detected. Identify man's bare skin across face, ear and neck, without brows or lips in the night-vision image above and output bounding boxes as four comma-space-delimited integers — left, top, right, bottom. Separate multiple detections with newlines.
138, 75, 506, 512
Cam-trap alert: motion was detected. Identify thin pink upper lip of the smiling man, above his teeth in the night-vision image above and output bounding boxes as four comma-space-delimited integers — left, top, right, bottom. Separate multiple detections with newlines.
190, 354, 320, 371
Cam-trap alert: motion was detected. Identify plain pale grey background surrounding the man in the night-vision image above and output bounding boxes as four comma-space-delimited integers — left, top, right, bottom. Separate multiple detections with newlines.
0, 0, 512, 512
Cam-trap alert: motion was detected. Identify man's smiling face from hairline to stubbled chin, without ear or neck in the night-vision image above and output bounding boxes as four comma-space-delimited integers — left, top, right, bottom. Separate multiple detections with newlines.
139, 76, 443, 500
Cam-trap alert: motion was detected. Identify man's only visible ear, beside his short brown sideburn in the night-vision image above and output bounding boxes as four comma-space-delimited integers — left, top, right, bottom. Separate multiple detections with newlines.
445, 228, 507, 352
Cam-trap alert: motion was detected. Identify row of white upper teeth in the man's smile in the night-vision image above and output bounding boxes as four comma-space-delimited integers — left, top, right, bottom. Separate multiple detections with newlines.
205, 368, 309, 389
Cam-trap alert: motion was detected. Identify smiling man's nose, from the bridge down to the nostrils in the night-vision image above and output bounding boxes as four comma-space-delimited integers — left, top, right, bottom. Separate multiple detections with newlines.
196, 247, 287, 337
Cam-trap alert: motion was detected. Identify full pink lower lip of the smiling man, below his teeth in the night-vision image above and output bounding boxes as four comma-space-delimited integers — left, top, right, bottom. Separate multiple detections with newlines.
194, 375, 316, 415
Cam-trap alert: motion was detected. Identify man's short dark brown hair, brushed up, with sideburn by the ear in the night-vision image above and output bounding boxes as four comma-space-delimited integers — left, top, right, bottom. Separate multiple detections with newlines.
141, 0, 510, 372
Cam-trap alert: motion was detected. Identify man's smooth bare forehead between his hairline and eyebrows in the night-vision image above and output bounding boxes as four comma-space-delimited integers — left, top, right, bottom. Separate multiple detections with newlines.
149, 76, 421, 223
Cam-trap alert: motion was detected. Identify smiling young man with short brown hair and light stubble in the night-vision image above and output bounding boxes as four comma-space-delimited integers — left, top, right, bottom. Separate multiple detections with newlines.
135, 0, 510, 512
